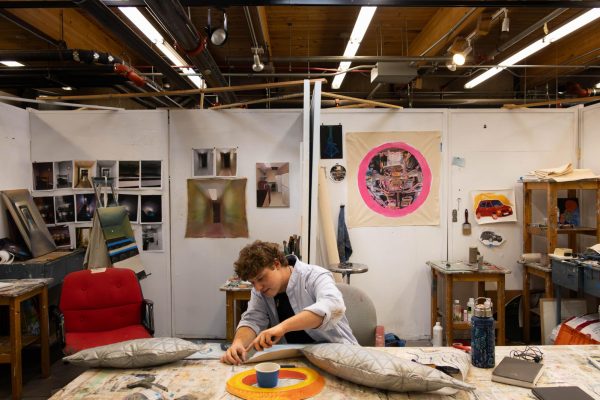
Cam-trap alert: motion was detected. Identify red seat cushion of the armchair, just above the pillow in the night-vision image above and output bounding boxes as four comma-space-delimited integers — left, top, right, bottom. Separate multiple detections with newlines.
64, 325, 152, 355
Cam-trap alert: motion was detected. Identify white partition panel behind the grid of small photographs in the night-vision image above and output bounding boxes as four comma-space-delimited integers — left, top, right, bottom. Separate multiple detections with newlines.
29, 111, 171, 336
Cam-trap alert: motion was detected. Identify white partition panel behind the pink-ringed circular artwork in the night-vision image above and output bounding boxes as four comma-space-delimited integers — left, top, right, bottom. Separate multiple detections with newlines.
315, 109, 447, 339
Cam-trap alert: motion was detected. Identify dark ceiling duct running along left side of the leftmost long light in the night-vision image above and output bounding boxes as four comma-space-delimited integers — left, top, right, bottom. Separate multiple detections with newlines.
73, 0, 194, 89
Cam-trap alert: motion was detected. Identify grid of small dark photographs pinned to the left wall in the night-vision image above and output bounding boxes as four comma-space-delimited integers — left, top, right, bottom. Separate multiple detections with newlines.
32, 158, 164, 252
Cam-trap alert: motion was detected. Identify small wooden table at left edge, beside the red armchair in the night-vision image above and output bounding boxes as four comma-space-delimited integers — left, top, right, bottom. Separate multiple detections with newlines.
0, 279, 52, 399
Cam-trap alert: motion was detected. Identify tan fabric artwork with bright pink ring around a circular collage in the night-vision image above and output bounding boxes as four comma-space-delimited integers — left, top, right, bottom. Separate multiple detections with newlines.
346, 131, 441, 228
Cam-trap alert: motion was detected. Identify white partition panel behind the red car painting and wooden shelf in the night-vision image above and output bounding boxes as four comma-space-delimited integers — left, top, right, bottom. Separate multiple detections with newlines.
444, 108, 578, 290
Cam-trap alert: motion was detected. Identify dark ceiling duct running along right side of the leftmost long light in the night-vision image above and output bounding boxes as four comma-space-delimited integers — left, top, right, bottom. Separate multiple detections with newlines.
145, 0, 237, 103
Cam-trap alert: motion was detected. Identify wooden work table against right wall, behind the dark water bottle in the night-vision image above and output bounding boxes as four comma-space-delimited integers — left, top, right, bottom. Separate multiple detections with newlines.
427, 261, 511, 346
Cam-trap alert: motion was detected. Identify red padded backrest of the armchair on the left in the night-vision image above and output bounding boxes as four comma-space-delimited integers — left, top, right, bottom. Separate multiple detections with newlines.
60, 268, 143, 332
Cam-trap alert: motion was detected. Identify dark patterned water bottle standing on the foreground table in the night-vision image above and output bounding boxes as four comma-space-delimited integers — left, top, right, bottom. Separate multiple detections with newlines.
471, 297, 496, 368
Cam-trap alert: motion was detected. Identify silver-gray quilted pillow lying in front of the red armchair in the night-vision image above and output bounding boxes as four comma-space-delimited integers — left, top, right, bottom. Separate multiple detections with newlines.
63, 338, 200, 368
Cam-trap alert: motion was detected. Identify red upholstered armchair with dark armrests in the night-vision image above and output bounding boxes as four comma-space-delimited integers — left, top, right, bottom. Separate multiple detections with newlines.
59, 268, 154, 354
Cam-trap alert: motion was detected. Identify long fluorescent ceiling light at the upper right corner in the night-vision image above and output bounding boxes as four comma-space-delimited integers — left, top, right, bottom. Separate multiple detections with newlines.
465, 8, 600, 89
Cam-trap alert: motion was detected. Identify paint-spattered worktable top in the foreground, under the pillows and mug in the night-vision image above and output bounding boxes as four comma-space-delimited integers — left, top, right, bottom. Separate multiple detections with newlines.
51, 345, 600, 400
